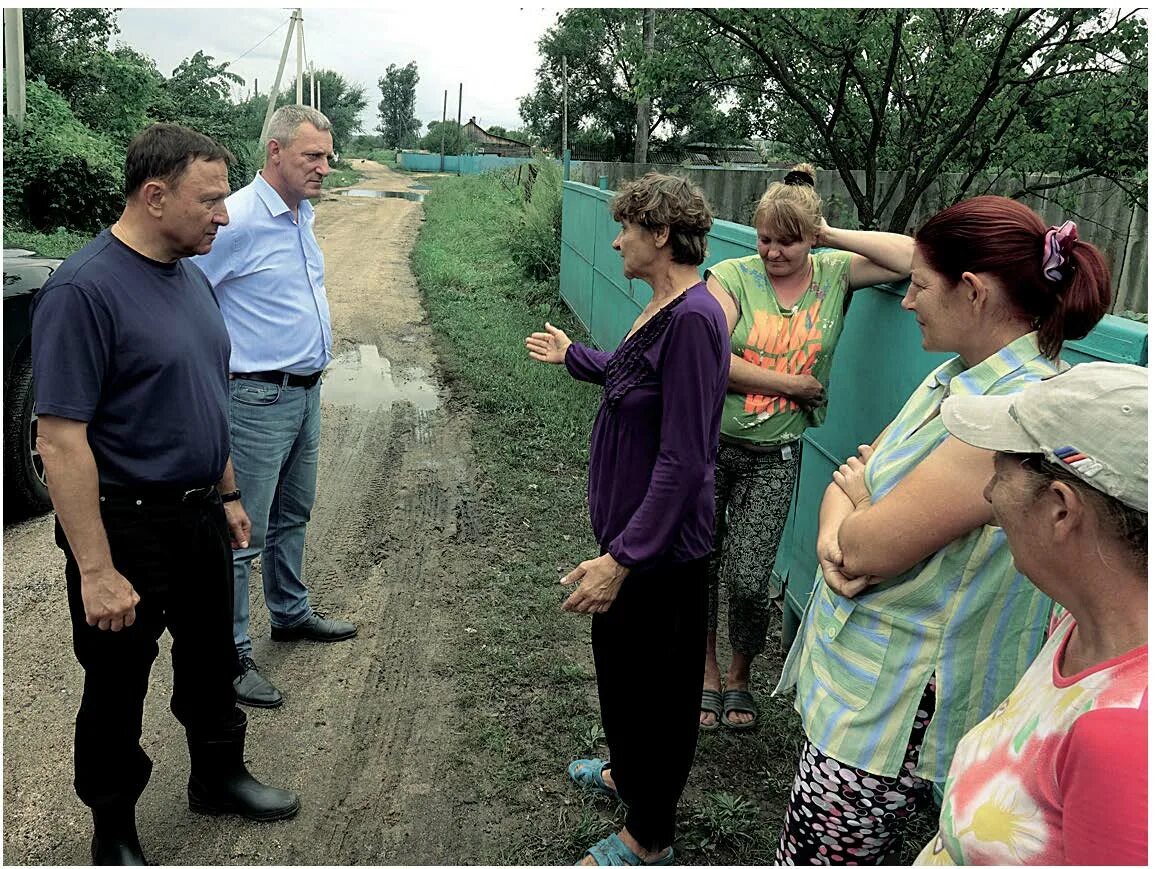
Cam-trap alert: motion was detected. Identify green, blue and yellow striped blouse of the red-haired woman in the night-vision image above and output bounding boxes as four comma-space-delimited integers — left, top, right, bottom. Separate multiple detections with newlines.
777, 333, 1064, 781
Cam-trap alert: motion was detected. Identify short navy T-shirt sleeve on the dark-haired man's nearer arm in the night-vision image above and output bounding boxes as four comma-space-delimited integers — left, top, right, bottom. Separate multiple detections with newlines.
32, 283, 116, 422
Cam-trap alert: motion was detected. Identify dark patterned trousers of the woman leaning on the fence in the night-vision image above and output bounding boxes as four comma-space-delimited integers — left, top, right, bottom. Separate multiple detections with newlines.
706, 441, 802, 656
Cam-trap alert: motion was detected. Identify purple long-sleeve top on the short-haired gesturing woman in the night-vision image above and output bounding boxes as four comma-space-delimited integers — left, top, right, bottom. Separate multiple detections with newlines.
565, 283, 731, 567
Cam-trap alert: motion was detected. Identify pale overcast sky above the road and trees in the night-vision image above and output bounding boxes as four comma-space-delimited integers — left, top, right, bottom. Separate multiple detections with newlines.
113, 0, 562, 133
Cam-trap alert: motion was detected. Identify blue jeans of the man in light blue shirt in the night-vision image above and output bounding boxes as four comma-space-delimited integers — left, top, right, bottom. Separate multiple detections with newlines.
229, 378, 321, 656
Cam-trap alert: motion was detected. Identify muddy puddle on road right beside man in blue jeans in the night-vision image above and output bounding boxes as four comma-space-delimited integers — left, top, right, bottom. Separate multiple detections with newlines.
321, 344, 438, 410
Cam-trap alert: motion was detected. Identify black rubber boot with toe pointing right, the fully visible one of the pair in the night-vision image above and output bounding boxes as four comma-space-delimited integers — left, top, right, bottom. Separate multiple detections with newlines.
188, 723, 301, 820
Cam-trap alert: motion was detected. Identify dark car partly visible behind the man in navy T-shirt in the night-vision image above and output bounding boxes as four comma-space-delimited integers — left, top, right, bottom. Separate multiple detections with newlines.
3, 244, 60, 515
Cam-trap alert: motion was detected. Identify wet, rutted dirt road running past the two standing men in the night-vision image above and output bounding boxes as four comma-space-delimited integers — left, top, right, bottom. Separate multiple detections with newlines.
3, 163, 489, 864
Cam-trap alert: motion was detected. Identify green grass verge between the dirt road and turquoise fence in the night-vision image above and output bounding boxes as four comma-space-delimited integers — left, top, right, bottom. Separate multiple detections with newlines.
413, 167, 931, 864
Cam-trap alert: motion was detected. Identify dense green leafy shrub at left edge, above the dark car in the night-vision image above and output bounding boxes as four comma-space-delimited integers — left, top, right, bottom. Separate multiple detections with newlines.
3, 81, 124, 231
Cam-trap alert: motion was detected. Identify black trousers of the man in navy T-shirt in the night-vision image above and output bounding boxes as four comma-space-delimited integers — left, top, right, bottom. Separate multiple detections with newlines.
57, 495, 245, 808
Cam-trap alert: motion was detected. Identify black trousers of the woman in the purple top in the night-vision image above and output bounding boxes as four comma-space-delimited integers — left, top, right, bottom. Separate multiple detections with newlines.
591, 557, 710, 851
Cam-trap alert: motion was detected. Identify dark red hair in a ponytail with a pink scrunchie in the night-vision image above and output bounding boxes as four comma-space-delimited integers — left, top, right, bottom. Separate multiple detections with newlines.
916, 196, 1112, 358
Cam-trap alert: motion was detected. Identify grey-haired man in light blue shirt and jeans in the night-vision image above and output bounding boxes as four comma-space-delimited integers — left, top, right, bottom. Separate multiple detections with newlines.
193, 105, 357, 707
